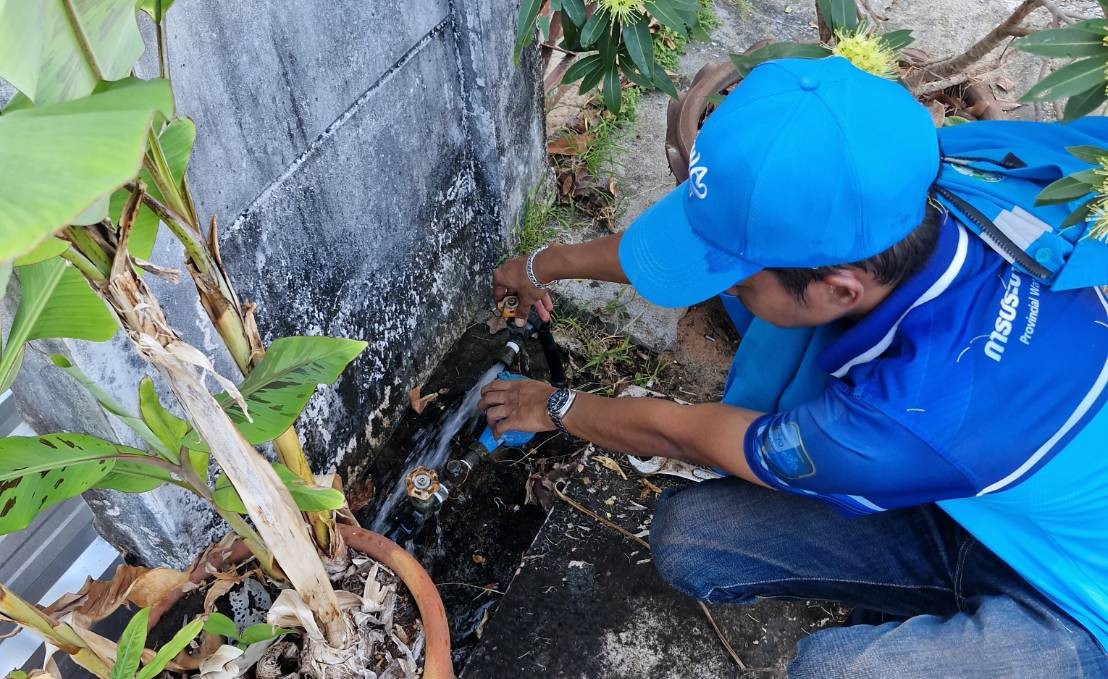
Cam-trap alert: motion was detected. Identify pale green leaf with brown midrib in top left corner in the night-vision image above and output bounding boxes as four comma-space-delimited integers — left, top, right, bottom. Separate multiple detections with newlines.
0, 0, 145, 104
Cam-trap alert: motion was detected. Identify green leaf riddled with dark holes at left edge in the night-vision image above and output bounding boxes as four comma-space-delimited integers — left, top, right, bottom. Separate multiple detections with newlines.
0, 433, 143, 534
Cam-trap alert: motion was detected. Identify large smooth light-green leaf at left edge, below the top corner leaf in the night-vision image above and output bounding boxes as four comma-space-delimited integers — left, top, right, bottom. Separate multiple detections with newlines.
0, 77, 173, 259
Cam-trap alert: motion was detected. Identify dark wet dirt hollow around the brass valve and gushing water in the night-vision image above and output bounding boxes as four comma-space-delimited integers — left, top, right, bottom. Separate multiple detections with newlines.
351, 325, 579, 671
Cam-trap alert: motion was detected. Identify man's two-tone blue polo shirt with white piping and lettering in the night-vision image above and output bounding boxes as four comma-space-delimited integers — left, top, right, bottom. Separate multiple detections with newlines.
740, 218, 1108, 648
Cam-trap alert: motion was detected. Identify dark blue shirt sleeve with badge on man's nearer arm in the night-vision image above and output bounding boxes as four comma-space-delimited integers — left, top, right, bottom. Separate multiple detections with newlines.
743, 382, 974, 515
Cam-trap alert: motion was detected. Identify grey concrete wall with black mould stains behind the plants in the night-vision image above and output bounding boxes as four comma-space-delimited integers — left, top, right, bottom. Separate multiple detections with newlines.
8, 0, 545, 566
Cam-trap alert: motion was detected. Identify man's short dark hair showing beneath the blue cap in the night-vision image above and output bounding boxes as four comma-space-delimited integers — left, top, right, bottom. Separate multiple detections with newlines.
766, 203, 942, 302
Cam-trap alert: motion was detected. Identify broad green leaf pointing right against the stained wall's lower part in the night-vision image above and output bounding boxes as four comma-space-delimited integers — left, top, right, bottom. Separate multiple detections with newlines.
199, 337, 366, 450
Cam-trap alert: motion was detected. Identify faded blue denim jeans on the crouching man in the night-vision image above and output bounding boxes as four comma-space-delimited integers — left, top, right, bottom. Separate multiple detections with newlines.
650, 477, 1108, 679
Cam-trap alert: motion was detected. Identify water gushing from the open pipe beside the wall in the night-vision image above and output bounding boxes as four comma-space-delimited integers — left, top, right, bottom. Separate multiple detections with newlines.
370, 361, 504, 534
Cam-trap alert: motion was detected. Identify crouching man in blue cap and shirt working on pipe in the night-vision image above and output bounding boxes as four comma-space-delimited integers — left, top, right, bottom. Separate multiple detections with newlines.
481, 58, 1108, 679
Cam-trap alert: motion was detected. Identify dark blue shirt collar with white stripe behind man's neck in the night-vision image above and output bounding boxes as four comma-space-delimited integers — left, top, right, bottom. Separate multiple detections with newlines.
818, 215, 970, 378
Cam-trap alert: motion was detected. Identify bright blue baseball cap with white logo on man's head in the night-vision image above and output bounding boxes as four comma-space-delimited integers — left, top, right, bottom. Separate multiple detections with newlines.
619, 56, 938, 307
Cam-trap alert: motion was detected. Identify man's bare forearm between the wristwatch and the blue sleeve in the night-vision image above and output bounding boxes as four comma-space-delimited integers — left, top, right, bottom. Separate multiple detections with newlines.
564, 393, 765, 485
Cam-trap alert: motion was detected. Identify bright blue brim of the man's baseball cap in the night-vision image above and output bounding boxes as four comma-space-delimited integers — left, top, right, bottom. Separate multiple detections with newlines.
619, 182, 765, 307
